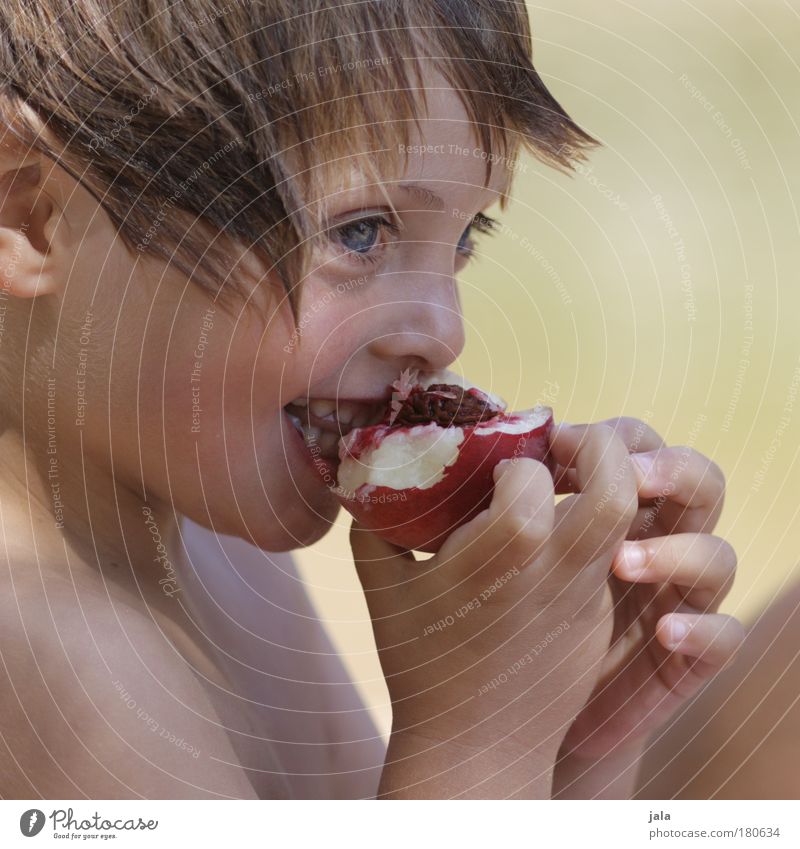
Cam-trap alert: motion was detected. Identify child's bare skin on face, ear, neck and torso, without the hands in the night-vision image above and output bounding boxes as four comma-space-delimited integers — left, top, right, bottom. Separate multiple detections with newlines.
0, 79, 505, 798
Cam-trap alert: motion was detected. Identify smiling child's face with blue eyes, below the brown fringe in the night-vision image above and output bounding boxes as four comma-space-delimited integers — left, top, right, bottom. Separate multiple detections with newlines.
53, 84, 505, 550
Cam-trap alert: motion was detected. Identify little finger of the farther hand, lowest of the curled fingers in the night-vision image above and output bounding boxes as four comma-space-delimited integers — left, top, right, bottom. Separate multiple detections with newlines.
656, 613, 745, 677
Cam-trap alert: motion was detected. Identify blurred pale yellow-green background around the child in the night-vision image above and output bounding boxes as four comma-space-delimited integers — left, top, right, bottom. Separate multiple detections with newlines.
297, 0, 800, 731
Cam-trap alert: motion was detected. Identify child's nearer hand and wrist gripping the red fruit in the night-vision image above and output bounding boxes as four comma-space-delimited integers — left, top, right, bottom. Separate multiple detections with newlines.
351, 425, 638, 798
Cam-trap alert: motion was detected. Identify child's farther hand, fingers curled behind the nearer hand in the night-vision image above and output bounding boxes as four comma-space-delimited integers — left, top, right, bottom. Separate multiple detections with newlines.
556, 419, 744, 764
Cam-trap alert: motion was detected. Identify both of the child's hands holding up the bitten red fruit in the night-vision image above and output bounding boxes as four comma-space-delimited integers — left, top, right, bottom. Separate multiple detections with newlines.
360, 419, 743, 798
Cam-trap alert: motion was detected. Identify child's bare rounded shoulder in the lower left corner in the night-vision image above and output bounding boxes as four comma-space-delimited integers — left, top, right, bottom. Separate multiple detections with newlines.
0, 568, 255, 799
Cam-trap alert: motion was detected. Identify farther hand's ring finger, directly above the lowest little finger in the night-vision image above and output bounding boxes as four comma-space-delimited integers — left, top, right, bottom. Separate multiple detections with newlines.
611, 534, 736, 610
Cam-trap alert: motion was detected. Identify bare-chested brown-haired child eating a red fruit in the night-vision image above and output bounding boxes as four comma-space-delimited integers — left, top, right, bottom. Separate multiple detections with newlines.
0, 0, 741, 798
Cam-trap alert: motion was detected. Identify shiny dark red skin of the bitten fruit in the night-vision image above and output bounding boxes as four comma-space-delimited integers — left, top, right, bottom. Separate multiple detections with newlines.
340, 407, 553, 553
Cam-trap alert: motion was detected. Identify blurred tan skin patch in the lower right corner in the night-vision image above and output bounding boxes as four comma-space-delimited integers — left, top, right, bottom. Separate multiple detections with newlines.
637, 580, 800, 799
